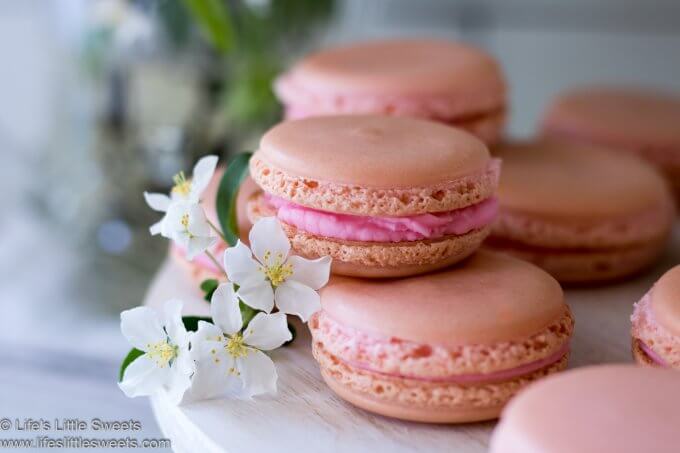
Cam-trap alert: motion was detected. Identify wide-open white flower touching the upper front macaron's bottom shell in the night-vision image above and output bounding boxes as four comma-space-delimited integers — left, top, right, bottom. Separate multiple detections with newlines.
224, 217, 331, 322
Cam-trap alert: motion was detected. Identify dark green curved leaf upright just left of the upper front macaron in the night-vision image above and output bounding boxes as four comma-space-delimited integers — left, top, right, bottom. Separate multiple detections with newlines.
216, 153, 253, 246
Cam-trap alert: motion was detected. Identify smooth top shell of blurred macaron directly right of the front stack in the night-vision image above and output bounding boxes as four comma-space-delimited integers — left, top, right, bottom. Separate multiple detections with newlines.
494, 141, 670, 219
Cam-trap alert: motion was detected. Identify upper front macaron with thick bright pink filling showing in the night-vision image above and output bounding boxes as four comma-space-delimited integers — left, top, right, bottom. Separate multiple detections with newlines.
248, 115, 499, 277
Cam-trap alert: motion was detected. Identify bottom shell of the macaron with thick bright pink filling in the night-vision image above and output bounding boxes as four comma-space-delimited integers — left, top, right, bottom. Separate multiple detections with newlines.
248, 194, 491, 278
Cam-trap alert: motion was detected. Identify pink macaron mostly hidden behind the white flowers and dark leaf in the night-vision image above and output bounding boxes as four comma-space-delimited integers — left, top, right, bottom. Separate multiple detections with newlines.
170, 167, 259, 284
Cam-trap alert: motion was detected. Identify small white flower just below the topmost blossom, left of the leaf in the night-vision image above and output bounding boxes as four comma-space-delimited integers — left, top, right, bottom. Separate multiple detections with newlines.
161, 202, 217, 261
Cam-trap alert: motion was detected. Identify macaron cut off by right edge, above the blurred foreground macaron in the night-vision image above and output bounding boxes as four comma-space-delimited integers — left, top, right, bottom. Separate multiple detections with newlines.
631, 265, 680, 369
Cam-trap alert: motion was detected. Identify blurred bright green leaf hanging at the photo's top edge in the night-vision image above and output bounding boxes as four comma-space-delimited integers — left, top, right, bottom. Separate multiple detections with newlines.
183, 0, 236, 54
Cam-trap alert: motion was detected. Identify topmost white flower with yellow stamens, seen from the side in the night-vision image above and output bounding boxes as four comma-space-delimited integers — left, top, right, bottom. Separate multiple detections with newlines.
144, 156, 217, 235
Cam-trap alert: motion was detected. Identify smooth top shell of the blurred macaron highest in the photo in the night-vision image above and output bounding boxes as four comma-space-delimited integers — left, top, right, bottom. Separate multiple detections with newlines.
284, 40, 504, 95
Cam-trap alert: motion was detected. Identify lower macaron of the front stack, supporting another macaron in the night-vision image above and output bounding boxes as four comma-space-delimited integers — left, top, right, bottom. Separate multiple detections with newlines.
309, 251, 574, 423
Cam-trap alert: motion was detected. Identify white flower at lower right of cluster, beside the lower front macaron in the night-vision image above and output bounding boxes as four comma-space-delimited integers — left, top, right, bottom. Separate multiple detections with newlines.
191, 282, 292, 398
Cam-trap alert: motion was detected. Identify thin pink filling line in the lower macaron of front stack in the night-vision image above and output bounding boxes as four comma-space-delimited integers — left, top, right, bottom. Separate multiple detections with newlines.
341, 343, 569, 384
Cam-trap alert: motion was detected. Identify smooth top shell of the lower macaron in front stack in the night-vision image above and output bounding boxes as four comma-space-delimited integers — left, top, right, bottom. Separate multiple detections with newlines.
321, 251, 565, 346
